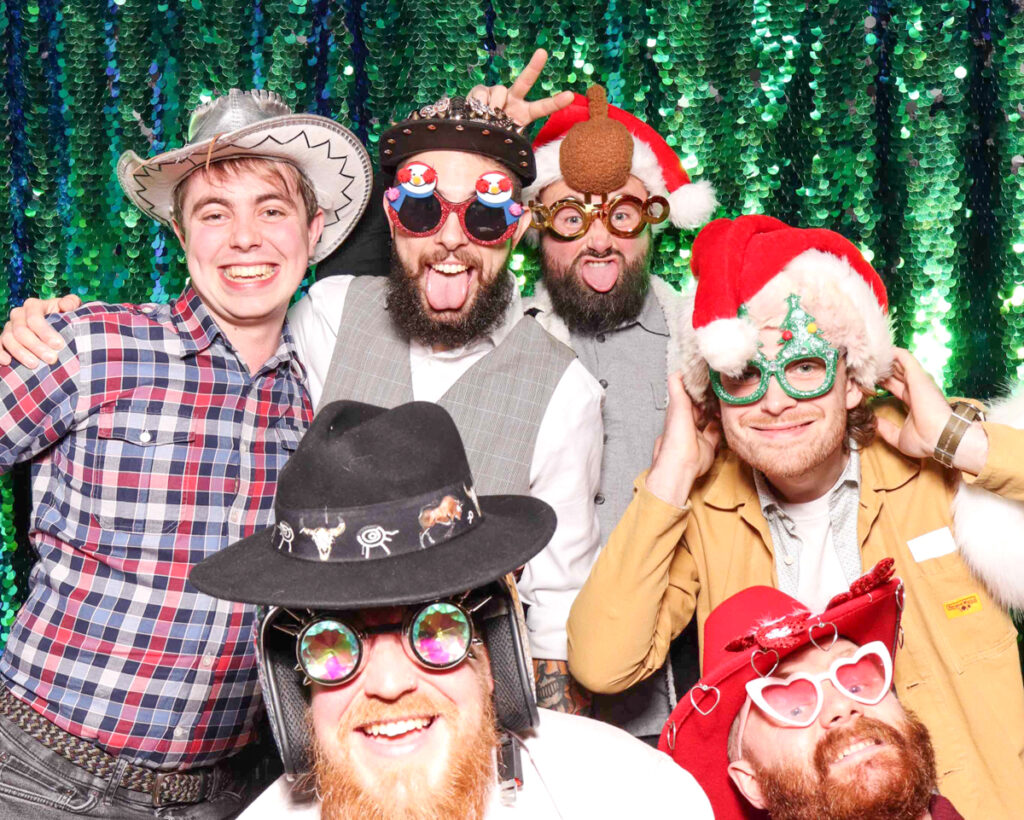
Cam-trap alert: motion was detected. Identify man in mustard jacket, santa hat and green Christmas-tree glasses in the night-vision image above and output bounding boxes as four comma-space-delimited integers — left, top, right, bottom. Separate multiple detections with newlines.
567, 215, 1024, 818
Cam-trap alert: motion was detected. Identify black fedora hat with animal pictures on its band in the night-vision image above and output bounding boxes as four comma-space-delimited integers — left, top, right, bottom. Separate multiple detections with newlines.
189, 401, 555, 609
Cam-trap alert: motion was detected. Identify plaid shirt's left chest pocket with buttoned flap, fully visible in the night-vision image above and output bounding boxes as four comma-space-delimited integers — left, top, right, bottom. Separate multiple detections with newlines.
89, 402, 196, 533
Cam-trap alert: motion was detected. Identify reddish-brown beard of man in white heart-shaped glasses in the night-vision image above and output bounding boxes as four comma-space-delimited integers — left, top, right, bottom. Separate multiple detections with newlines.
751, 713, 936, 820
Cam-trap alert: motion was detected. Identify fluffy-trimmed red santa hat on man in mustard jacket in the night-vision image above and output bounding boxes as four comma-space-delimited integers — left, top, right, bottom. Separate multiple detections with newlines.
675, 216, 893, 401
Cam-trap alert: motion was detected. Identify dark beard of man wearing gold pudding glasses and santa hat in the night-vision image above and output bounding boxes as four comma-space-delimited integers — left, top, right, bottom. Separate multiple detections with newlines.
541, 247, 651, 336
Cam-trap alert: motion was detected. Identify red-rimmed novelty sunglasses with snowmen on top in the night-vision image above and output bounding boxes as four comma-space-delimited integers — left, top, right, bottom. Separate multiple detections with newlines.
385, 163, 523, 246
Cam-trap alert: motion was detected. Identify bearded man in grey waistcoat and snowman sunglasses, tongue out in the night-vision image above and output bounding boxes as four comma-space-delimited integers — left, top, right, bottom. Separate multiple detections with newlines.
291, 51, 602, 710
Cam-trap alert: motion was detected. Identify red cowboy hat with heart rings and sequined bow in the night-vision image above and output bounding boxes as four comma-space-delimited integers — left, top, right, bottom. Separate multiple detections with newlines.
657, 558, 903, 820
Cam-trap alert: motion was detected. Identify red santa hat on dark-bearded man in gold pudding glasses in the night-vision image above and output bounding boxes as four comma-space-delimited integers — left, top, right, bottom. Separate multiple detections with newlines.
523, 89, 718, 229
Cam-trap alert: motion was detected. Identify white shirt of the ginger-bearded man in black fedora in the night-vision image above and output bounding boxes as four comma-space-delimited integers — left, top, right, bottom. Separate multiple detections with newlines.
241, 709, 715, 820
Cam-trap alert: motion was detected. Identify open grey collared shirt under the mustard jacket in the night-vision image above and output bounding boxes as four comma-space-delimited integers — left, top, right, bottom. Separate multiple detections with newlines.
754, 448, 862, 598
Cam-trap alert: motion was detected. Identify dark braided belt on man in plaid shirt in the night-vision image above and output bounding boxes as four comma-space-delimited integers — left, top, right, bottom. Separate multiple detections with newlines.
0, 686, 217, 807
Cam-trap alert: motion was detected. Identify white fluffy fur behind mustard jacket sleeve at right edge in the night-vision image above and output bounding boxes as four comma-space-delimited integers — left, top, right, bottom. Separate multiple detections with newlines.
953, 386, 1024, 609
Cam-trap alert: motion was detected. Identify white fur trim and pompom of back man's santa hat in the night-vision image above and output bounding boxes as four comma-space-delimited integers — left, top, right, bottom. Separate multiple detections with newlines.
522, 136, 718, 232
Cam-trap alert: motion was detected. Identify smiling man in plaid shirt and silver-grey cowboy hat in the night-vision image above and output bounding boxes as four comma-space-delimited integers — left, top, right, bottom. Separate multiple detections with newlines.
0, 89, 371, 820
